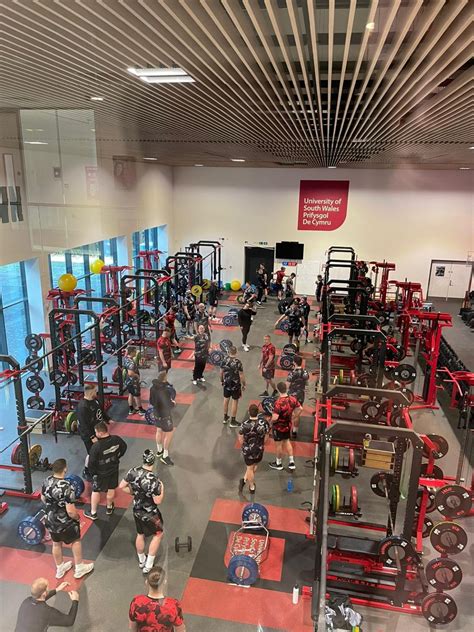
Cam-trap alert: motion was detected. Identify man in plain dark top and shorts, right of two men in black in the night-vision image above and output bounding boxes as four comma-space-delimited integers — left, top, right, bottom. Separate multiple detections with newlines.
150, 371, 176, 465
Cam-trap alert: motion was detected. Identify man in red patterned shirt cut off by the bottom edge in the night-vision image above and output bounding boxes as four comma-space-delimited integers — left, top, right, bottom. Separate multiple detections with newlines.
128, 566, 186, 632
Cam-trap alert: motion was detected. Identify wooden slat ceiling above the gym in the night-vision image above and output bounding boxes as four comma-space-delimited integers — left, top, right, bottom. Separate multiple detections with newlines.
0, 0, 474, 168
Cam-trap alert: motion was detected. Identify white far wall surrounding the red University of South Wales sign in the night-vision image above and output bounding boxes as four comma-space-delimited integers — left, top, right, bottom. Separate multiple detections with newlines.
173, 167, 474, 288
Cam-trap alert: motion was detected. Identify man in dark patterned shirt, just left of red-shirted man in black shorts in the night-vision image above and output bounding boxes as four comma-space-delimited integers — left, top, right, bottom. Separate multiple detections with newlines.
239, 404, 270, 494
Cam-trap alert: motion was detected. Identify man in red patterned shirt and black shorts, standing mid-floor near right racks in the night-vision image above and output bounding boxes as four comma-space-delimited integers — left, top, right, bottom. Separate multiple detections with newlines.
268, 382, 301, 471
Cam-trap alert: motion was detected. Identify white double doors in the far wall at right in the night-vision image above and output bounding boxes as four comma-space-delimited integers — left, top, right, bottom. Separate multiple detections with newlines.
427, 260, 472, 301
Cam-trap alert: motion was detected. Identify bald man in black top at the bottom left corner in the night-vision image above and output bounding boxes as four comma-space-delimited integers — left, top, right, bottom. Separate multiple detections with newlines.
15, 577, 79, 632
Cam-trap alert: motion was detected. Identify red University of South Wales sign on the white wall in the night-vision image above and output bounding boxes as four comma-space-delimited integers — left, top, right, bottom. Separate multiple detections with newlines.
298, 180, 349, 230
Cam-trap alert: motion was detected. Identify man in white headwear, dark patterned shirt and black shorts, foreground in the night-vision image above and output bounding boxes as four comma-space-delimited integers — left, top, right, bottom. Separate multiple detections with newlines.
119, 450, 165, 574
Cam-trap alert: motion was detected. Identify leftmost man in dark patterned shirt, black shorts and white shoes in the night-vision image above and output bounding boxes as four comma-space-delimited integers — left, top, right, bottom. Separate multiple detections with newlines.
41, 459, 94, 579
